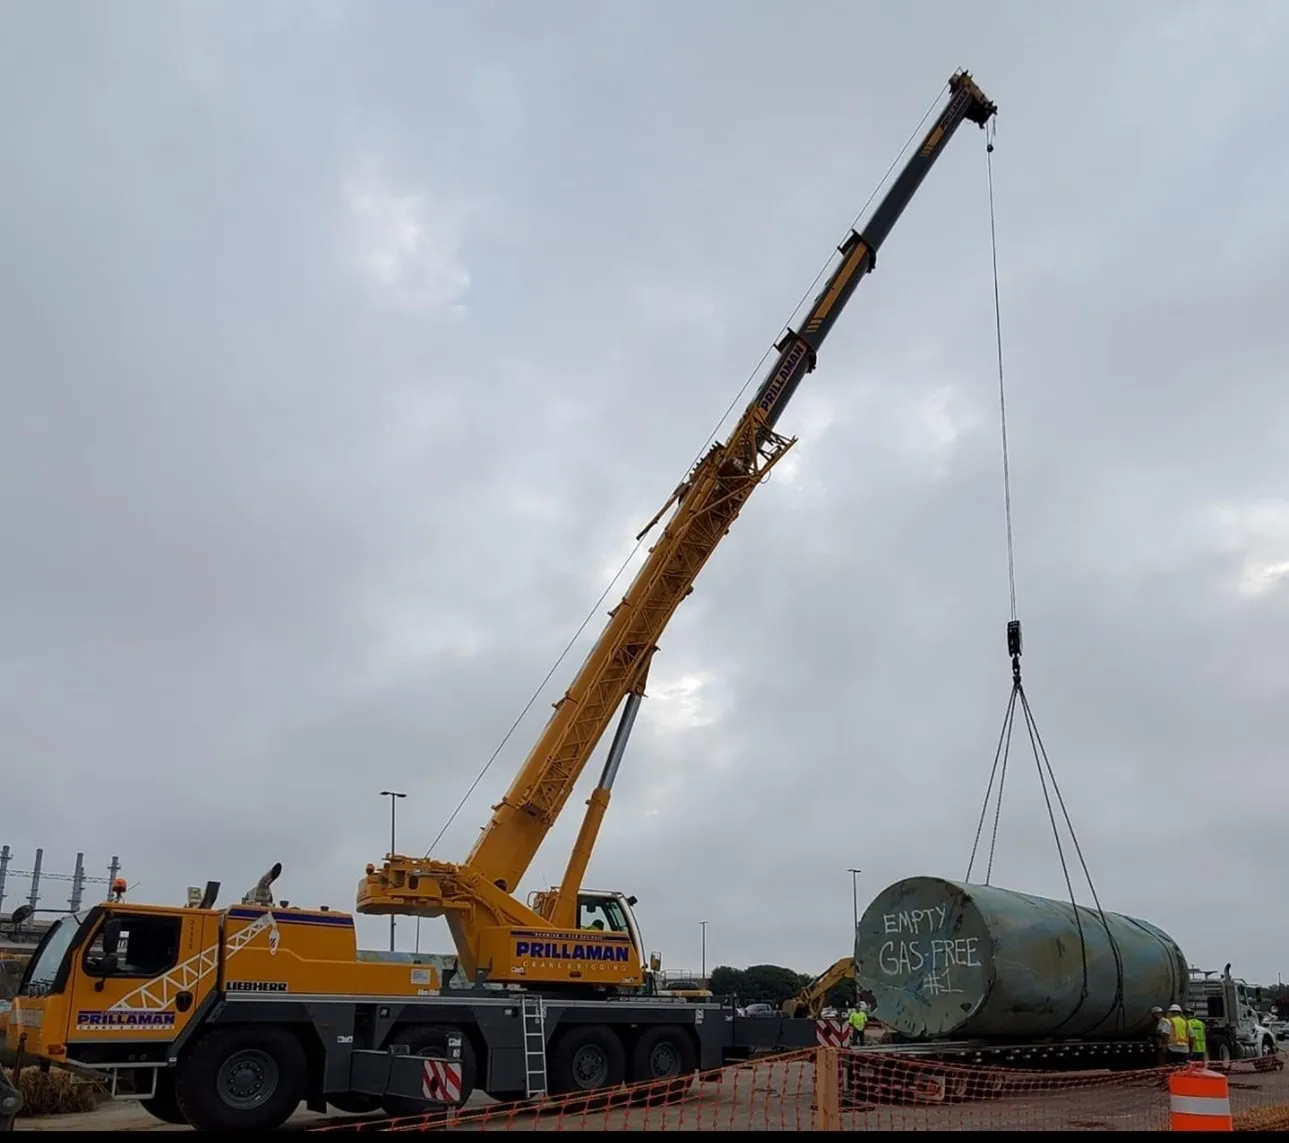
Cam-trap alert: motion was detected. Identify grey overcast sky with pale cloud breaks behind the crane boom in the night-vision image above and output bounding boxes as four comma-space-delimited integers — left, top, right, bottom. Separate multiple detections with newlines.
0, 0, 1289, 981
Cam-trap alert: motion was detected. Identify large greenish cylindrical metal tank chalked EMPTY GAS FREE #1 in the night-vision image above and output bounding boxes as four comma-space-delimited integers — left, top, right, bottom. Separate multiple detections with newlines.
855, 878, 1187, 1041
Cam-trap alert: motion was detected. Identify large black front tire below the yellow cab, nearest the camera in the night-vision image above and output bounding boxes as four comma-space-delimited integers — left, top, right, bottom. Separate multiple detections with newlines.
175, 1024, 308, 1131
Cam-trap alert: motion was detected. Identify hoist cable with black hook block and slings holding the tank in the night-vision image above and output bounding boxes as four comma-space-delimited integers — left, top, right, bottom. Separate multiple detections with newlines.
964, 121, 1127, 1028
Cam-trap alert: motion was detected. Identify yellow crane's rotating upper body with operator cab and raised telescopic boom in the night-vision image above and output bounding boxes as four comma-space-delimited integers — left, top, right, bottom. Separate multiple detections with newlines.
357, 72, 996, 991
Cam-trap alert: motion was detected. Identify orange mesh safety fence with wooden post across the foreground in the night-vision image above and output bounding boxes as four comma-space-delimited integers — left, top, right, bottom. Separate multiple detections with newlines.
313, 1048, 1289, 1131
